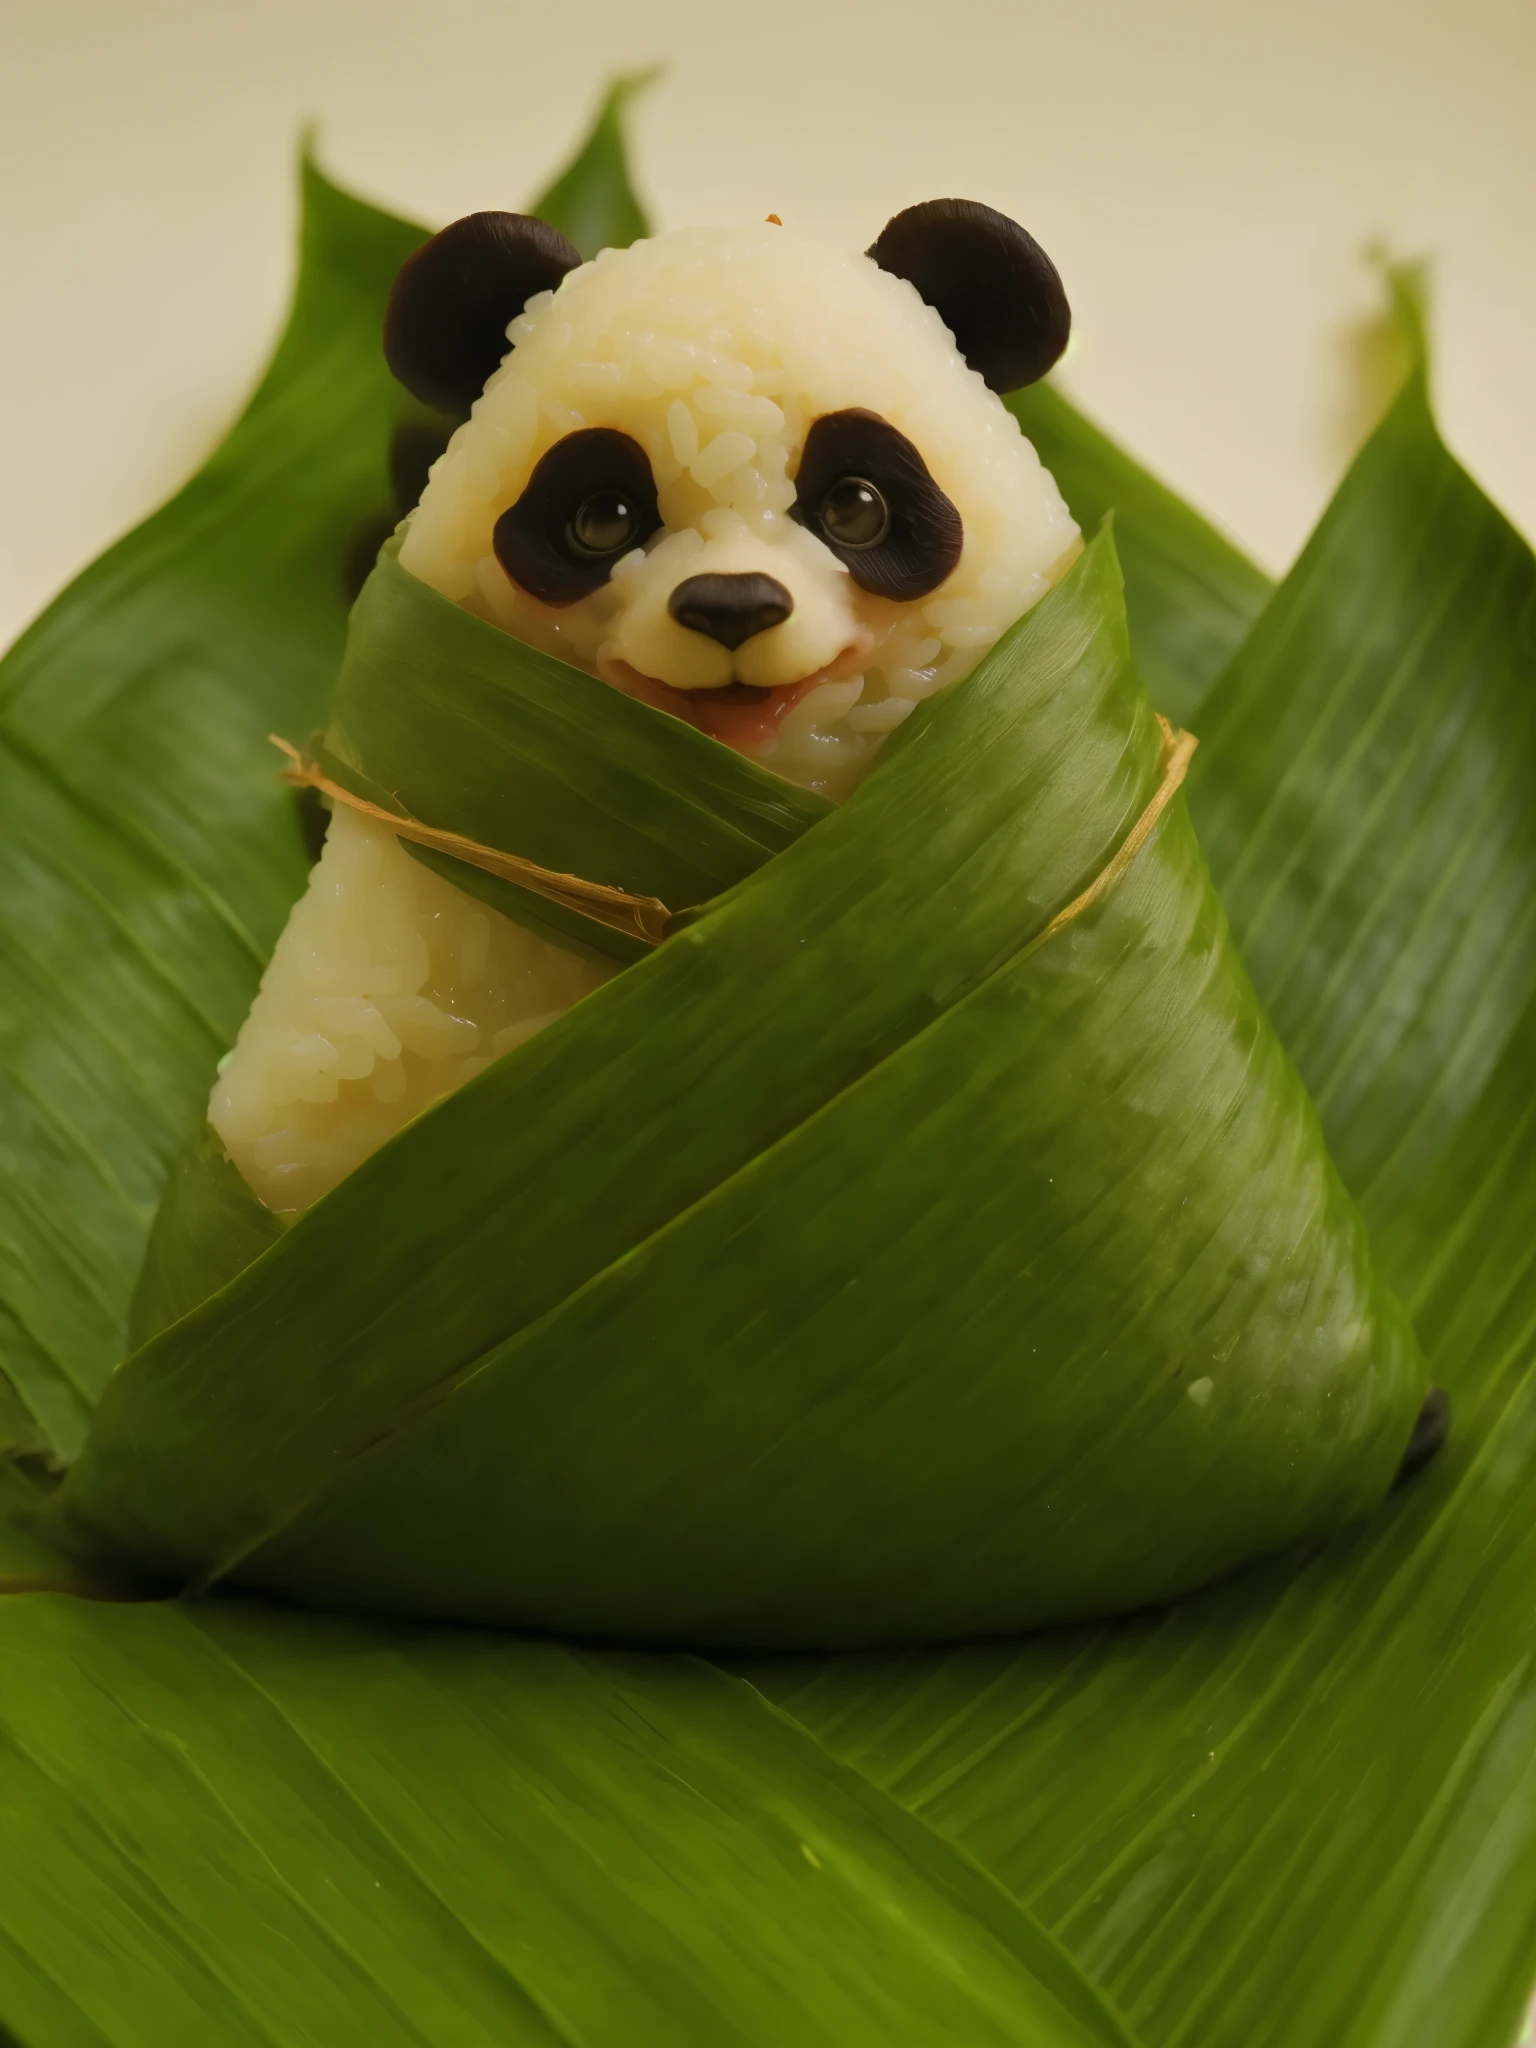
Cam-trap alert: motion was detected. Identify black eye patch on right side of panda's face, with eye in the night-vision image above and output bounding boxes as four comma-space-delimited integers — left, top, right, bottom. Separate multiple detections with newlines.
791, 406, 965, 604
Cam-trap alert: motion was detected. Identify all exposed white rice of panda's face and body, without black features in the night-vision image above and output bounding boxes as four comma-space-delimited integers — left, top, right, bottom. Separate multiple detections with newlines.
209, 225, 1081, 1214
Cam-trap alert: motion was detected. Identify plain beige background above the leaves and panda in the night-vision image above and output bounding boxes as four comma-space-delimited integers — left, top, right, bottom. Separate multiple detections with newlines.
0, 0, 1536, 643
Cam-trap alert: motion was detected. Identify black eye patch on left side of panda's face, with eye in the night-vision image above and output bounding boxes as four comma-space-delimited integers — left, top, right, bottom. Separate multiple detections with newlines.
492, 426, 662, 604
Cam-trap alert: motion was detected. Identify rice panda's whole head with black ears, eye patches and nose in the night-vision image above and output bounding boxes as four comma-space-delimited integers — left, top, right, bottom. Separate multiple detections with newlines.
385, 201, 1079, 795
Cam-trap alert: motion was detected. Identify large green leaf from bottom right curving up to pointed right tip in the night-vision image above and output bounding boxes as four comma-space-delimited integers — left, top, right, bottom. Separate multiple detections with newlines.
774, 379, 1536, 2048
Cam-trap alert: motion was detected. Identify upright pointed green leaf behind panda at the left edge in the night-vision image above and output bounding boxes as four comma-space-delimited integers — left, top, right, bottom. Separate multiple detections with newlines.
0, 164, 420, 1456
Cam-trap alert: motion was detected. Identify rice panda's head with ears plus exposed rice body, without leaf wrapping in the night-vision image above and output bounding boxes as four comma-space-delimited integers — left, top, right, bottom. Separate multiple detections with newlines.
209, 201, 1081, 1214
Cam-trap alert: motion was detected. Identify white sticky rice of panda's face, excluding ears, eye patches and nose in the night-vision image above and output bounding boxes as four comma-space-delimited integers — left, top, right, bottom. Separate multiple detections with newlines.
399, 223, 1081, 797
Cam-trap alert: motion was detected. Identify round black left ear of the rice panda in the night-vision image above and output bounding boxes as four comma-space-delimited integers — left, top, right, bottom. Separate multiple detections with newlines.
385, 213, 582, 414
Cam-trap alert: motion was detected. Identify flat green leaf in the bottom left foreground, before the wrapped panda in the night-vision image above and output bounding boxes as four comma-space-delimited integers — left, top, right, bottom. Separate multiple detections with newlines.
0, 1597, 1135, 2048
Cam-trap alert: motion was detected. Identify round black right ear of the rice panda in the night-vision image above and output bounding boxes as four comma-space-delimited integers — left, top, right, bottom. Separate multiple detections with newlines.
868, 199, 1071, 391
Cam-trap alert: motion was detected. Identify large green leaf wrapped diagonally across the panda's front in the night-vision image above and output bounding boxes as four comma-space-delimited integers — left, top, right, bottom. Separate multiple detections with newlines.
63, 535, 1425, 1645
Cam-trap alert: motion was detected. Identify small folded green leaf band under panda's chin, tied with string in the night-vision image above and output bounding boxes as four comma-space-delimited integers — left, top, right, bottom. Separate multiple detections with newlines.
324, 541, 831, 961
